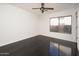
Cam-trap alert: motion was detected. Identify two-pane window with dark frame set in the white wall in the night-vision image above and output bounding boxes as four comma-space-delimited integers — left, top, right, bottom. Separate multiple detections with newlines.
50, 16, 72, 34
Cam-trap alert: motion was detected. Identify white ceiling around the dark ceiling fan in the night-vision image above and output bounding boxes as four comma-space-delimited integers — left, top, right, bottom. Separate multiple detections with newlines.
11, 3, 79, 14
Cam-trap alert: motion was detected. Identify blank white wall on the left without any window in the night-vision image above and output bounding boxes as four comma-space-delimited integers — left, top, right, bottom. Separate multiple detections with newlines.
0, 4, 38, 46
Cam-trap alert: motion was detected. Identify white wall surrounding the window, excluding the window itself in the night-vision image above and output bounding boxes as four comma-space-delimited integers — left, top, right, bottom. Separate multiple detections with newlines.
39, 9, 76, 42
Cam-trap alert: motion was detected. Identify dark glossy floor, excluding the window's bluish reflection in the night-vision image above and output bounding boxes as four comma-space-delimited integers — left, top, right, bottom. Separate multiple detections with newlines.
0, 35, 77, 56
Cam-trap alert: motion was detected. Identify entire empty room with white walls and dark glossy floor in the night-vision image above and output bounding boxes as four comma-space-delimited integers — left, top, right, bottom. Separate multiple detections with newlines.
0, 3, 79, 56
